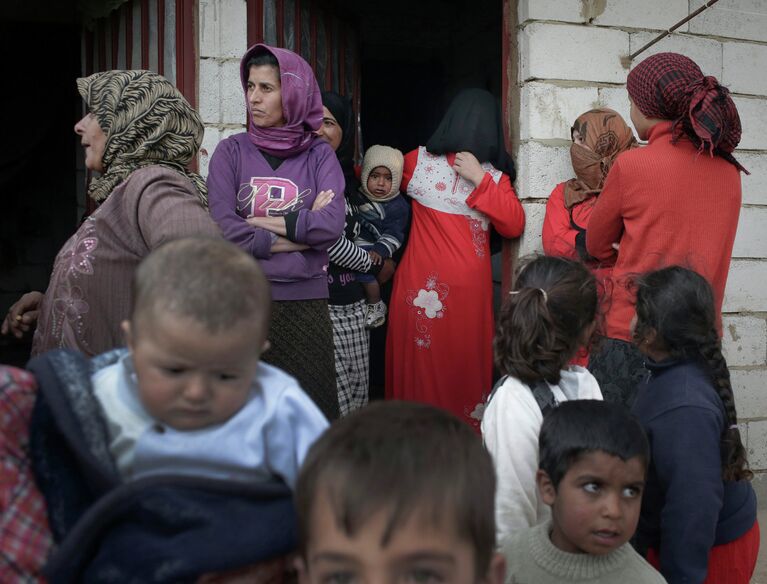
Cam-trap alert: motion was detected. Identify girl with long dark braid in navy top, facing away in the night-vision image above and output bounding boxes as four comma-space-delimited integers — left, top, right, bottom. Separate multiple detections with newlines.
633, 266, 759, 584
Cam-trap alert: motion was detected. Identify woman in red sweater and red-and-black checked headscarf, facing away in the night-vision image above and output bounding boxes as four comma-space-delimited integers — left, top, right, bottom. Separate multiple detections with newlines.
586, 53, 744, 404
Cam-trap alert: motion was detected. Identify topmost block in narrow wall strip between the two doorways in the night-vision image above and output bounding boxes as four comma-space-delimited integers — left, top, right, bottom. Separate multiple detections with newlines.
199, 0, 247, 59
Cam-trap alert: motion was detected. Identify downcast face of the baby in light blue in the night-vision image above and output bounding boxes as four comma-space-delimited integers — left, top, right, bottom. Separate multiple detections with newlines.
123, 314, 264, 430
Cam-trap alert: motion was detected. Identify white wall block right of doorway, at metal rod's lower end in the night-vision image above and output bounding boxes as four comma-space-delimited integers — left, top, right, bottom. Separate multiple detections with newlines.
519, 23, 629, 83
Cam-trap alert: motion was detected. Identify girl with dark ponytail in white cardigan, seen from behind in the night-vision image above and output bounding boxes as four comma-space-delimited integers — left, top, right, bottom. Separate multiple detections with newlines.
482, 257, 602, 544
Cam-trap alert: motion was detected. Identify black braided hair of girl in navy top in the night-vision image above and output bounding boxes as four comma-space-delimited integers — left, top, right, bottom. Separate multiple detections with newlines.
634, 266, 753, 480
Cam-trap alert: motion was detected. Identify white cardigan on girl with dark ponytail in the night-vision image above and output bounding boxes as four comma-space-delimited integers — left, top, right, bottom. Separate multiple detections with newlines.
482, 366, 602, 545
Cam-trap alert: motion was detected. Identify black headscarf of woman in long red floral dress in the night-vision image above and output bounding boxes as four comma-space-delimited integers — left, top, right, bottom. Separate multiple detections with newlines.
426, 89, 517, 182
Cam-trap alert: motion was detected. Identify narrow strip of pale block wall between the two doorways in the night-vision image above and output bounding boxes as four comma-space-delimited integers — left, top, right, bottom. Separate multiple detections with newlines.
198, 0, 248, 176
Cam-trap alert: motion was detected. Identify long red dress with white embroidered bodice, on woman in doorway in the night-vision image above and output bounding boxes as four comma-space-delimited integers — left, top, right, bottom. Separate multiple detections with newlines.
386, 147, 525, 428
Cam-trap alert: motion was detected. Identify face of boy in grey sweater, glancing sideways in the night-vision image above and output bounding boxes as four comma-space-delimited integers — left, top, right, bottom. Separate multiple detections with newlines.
538, 452, 645, 556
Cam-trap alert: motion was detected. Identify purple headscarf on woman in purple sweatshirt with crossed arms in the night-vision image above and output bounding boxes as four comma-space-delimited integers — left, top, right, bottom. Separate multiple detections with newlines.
240, 44, 322, 158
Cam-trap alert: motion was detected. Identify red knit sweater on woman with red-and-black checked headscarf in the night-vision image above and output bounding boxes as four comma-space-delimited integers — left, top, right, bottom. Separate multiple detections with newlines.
586, 122, 741, 341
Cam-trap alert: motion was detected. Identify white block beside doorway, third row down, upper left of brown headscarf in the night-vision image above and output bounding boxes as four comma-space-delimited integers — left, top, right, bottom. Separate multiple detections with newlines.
519, 83, 599, 140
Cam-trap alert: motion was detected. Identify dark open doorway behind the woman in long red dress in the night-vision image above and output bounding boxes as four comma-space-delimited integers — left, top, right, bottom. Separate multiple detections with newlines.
332, 0, 503, 399
